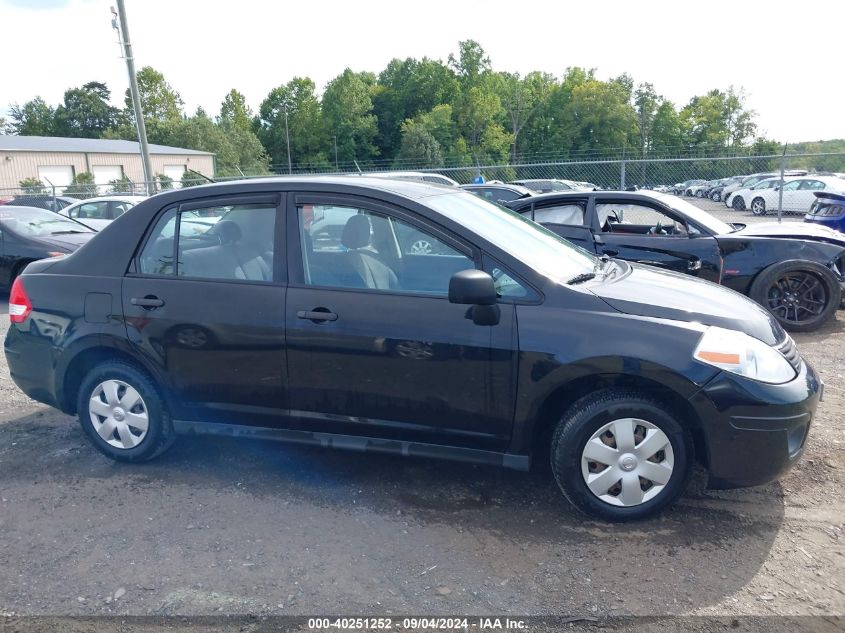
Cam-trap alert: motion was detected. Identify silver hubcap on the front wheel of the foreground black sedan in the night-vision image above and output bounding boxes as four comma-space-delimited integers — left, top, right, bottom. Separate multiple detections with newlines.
581, 418, 675, 507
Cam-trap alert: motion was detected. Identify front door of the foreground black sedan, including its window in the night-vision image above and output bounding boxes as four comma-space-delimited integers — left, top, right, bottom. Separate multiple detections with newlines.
286, 194, 517, 450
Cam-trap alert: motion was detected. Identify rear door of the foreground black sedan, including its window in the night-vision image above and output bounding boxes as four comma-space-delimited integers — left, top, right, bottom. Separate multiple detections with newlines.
123, 195, 288, 426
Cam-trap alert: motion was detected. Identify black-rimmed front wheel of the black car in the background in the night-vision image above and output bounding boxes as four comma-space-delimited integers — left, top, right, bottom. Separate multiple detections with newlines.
748, 261, 842, 332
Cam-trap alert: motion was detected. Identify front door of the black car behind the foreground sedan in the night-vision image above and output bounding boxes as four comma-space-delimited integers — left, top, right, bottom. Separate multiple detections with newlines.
595, 198, 722, 283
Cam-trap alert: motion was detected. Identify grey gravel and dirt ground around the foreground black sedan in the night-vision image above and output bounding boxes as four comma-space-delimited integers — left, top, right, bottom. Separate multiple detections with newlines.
0, 199, 845, 630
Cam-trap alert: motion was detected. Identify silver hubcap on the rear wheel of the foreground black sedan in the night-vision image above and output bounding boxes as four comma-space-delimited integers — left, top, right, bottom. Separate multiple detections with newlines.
88, 380, 150, 448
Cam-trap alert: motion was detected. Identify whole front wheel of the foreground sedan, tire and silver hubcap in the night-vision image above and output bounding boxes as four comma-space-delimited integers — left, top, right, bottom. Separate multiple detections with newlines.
551, 389, 692, 521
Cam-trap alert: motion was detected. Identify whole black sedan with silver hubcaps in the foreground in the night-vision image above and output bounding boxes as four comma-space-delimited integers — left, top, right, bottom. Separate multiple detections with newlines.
5, 177, 821, 520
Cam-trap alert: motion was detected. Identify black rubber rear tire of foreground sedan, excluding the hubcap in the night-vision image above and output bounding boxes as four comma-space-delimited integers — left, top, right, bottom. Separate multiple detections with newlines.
76, 360, 176, 462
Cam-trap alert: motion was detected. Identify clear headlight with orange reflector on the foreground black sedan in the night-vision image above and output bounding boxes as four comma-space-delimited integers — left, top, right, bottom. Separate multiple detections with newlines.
693, 327, 796, 385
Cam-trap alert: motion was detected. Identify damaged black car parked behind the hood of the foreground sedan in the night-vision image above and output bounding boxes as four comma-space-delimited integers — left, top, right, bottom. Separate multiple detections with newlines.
508, 191, 845, 331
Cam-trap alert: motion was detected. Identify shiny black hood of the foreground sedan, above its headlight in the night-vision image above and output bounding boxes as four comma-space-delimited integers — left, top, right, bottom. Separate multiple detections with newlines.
590, 264, 786, 345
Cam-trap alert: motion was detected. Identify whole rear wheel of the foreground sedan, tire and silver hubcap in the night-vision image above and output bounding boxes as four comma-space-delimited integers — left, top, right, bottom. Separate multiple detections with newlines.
77, 361, 175, 462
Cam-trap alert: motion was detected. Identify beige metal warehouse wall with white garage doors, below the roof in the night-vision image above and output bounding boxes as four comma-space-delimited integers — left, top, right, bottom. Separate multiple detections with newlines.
0, 150, 214, 189
